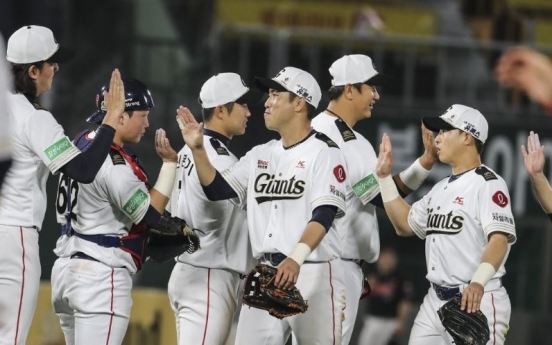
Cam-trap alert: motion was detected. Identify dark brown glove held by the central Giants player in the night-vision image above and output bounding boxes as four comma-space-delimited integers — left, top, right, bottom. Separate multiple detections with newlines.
242, 264, 309, 319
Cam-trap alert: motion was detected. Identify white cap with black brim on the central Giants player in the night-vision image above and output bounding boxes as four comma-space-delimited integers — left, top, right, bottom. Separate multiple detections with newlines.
255, 67, 322, 108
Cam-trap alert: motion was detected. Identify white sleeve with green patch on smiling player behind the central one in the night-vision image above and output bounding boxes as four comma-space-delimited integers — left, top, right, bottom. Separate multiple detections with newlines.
343, 139, 380, 205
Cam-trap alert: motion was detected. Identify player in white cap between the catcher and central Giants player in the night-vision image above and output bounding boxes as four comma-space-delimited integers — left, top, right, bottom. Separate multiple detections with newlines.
168, 73, 254, 345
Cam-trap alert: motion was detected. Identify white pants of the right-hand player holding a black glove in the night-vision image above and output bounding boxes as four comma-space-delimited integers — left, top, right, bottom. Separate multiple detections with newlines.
408, 280, 511, 345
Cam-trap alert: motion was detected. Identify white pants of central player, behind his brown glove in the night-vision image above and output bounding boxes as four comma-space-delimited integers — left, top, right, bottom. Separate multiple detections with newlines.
235, 259, 345, 345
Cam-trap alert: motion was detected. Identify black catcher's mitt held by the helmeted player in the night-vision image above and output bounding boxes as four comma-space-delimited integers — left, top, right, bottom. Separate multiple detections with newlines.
146, 214, 200, 262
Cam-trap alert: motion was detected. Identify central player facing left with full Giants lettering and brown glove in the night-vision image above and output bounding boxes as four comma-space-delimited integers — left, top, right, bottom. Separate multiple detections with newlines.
178, 67, 347, 345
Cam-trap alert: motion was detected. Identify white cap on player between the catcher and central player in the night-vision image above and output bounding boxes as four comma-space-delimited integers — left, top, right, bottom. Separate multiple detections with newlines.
199, 73, 258, 109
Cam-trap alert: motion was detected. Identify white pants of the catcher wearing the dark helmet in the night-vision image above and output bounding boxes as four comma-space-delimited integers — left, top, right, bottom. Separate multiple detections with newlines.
51, 258, 132, 345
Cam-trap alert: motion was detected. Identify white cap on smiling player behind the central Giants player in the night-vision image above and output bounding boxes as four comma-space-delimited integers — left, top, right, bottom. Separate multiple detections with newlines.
329, 54, 391, 86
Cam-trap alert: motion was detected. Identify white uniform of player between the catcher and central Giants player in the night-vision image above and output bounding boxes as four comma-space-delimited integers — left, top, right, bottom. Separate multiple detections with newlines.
168, 130, 254, 345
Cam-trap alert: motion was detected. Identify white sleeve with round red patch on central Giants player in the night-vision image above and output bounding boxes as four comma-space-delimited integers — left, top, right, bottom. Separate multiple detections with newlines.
310, 147, 349, 218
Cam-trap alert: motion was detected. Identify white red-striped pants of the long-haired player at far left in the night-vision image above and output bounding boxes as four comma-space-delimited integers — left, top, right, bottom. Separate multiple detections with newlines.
0, 225, 41, 345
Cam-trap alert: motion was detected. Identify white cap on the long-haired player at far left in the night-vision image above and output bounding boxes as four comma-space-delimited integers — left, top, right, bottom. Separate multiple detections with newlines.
6, 25, 75, 64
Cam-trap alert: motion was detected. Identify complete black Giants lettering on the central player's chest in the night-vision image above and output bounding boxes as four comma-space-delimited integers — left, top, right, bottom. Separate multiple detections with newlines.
255, 174, 305, 204
